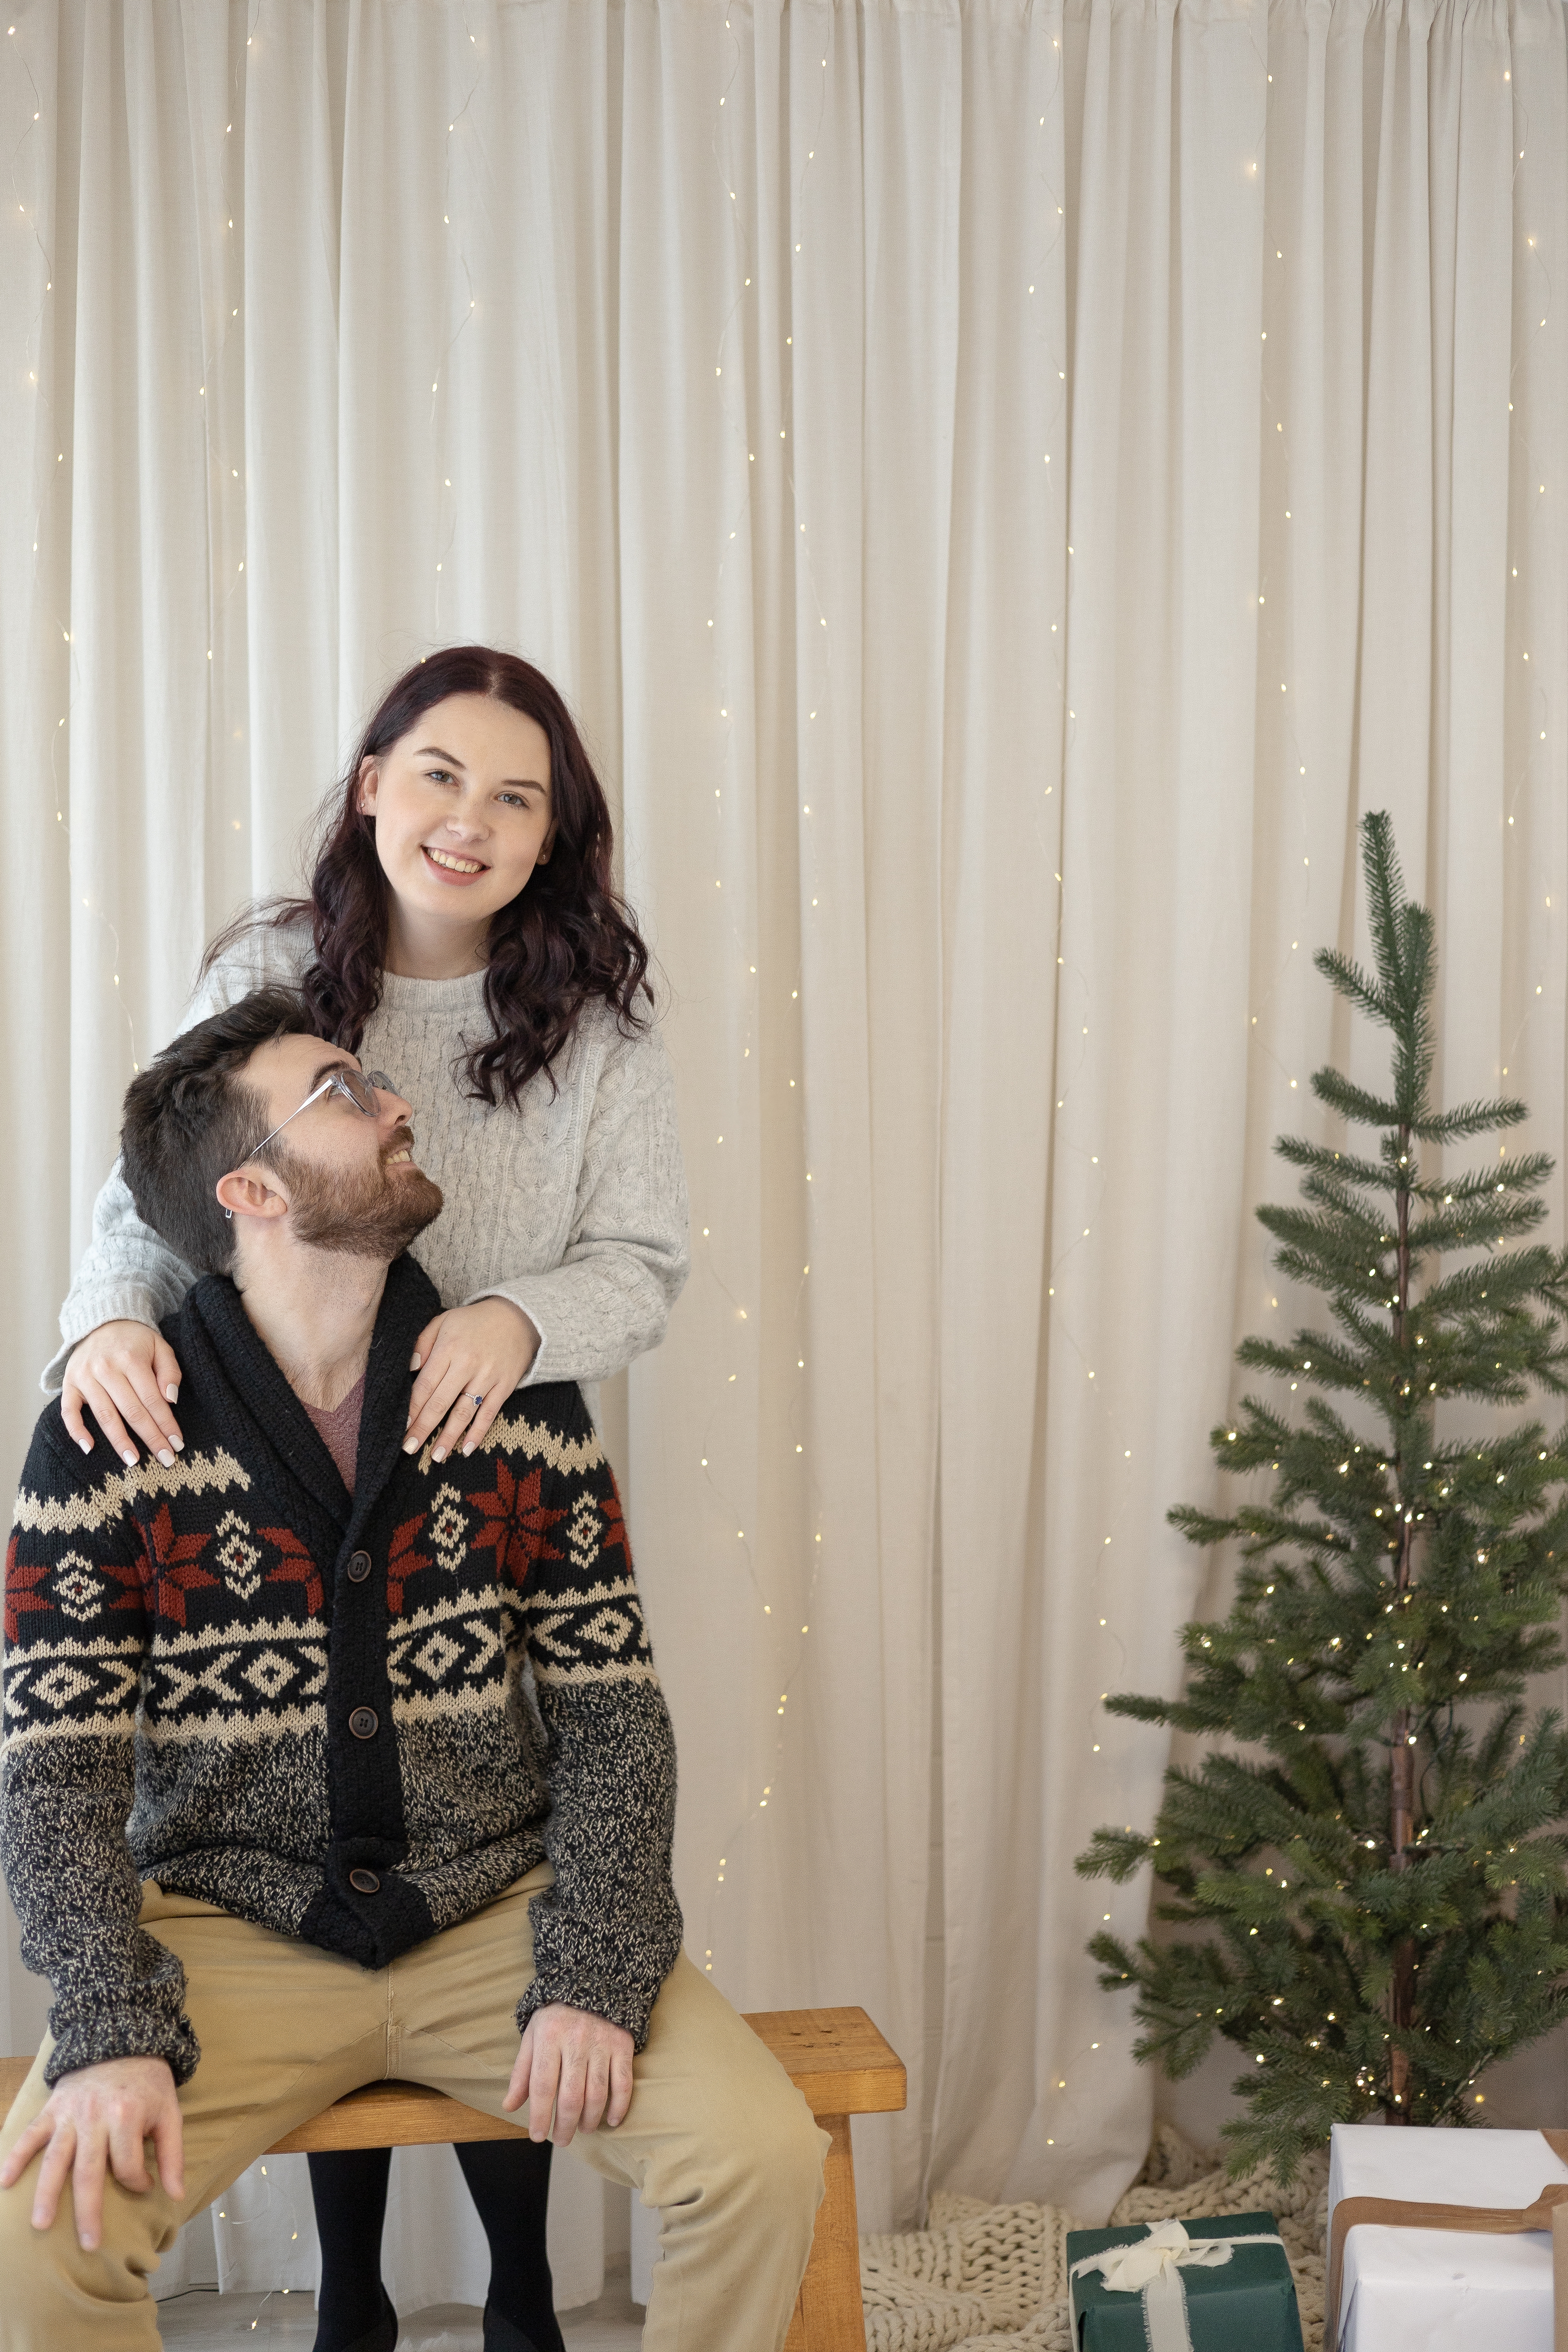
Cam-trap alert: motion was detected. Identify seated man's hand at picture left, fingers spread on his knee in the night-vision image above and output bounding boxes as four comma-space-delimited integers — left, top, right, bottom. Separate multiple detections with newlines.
0, 2051, 185, 2253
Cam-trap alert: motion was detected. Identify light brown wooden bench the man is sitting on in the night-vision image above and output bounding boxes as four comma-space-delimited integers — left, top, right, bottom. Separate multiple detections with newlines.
0, 2009, 905, 2352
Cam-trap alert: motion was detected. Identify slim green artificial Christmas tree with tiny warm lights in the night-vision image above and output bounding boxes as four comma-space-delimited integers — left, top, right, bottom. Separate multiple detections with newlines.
1077, 814, 1568, 2180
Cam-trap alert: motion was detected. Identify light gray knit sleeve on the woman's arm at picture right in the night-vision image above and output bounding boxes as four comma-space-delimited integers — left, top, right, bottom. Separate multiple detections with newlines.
465, 1030, 691, 1385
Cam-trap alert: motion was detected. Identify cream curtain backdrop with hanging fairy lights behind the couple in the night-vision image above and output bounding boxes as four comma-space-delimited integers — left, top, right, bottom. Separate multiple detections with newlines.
0, 0, 1568, 2293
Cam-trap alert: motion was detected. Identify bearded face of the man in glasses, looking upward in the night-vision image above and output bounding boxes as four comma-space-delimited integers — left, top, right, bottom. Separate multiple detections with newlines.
245, 1037, 442, 1263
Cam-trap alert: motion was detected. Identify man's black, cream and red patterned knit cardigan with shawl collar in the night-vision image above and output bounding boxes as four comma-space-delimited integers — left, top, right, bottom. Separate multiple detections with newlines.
0, 1258, 682, 2082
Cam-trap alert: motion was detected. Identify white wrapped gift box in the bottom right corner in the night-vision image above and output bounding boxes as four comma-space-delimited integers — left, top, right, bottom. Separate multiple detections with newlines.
1328, 2124, 1568, 2352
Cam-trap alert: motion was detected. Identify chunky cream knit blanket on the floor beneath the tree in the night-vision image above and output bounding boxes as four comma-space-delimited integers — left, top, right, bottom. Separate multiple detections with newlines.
860, 2124, 1328, 2352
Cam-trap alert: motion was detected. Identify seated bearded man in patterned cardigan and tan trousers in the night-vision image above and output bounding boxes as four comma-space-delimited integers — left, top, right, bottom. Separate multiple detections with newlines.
0, 990, 825, 2352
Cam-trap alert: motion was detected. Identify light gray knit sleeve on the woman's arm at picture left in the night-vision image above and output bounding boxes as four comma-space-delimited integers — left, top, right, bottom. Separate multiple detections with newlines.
37, 927, 306, 1397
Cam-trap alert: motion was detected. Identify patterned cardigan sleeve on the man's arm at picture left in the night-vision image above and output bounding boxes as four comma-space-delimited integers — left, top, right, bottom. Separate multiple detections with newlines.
0, 1411, 200, 2082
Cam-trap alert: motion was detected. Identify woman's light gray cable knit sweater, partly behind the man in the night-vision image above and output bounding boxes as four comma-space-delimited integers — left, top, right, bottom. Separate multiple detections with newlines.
40, 924, 689, 1395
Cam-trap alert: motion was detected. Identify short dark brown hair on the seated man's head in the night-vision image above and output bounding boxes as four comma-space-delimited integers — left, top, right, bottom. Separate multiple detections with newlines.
120, 988, 315, 1275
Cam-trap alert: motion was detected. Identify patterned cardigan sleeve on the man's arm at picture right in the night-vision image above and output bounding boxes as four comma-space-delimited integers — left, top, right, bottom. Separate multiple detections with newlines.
512, 1390, 682, 2049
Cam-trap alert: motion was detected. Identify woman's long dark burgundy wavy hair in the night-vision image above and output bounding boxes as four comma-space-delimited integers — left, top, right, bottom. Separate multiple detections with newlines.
202, 644, 654, 1105
